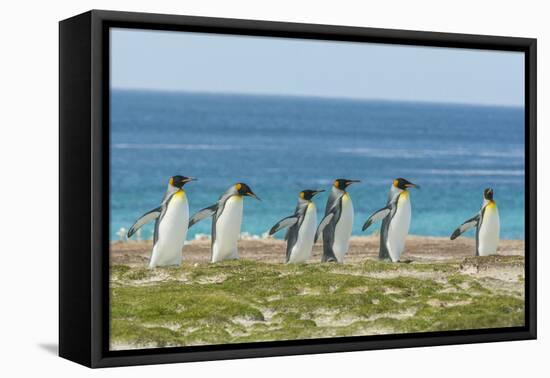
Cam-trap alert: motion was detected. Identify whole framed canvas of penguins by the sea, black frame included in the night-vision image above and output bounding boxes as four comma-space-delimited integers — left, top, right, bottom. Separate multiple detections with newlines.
59, 10, 536, 367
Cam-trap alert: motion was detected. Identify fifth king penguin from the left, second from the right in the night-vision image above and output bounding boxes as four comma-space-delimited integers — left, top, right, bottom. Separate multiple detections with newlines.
363, 178, 420, 262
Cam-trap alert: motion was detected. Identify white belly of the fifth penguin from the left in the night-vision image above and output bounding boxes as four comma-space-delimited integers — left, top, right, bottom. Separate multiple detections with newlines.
386, 192, 411, 262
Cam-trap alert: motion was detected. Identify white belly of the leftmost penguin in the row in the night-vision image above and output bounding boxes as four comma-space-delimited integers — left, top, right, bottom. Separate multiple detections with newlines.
149, 191, 189, 268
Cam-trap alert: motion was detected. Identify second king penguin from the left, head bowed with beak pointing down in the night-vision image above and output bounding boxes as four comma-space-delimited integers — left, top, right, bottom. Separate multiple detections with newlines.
189, 183, 259, 263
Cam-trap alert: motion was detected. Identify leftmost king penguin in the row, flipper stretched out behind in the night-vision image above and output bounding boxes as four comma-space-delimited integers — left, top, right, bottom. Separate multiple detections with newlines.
128, 176, 196, 268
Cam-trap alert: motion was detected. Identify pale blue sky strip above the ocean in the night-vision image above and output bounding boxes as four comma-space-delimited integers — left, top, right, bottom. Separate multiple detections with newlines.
111, 29, 524, 106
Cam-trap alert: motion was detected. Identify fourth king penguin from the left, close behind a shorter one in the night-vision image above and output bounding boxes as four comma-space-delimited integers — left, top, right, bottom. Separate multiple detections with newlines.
315, 179, 360, 263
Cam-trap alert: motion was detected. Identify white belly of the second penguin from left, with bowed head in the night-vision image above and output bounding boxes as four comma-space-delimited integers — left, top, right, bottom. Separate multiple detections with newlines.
212, 196, 243, 262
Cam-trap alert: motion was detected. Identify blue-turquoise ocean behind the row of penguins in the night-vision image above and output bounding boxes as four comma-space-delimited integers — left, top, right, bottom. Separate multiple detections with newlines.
110, 90, 525, 240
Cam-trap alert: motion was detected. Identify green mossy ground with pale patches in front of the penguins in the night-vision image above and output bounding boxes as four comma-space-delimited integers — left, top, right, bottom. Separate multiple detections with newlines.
110, 256, 524, 349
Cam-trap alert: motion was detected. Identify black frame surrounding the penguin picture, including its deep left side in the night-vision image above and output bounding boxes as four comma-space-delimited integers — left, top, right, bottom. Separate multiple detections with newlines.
59, 10, 537, 367
